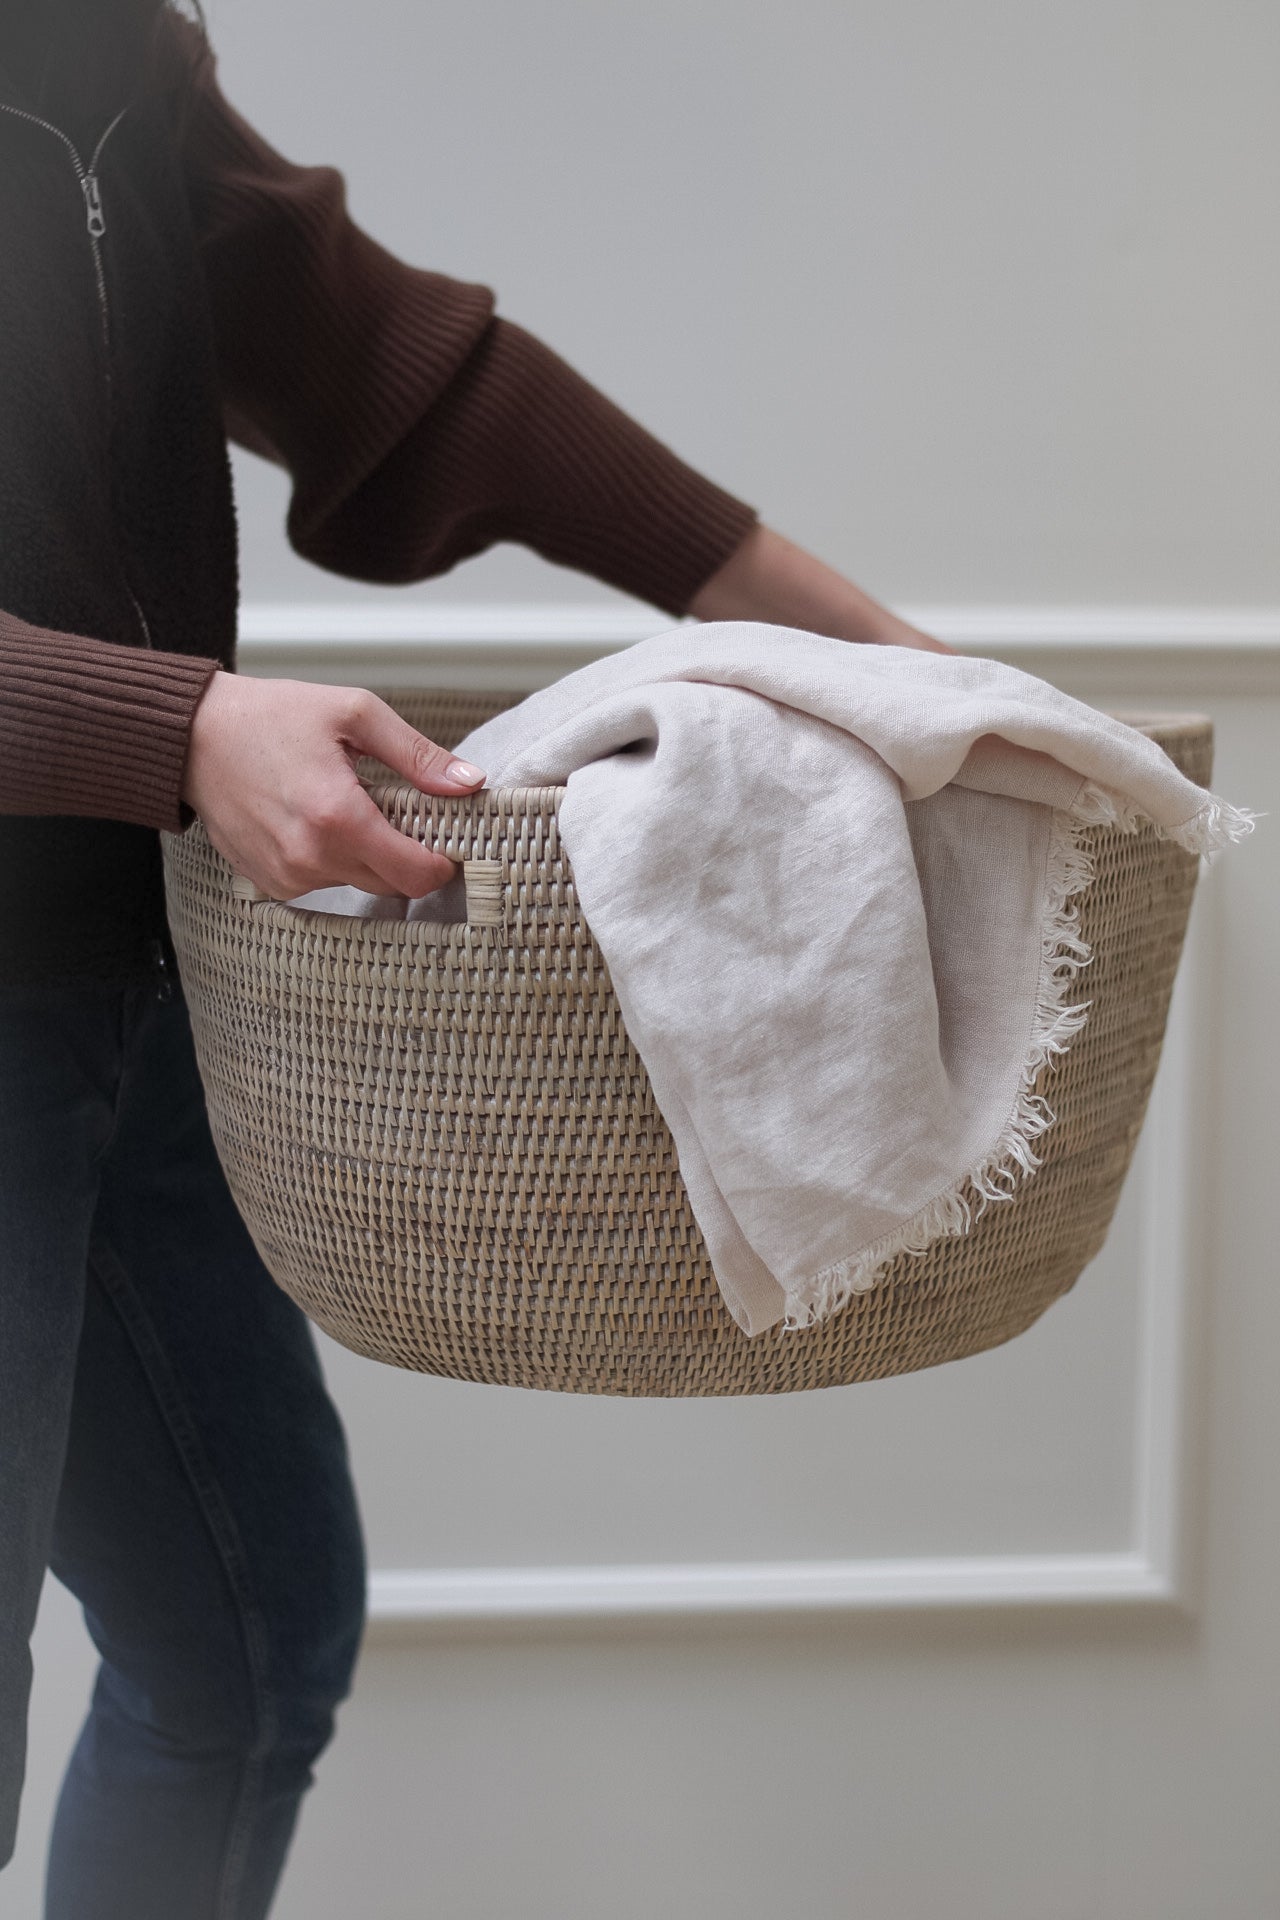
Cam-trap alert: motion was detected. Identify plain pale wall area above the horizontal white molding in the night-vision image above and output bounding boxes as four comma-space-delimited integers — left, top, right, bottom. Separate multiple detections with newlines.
213, 0, 1280, 603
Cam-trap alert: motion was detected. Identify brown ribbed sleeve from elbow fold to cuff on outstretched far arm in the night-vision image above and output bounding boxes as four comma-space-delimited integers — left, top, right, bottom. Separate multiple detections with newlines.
301, 319, 756, 614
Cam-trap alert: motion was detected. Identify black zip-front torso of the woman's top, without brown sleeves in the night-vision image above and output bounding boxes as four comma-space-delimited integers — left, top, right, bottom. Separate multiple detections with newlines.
0, 37, 236, 981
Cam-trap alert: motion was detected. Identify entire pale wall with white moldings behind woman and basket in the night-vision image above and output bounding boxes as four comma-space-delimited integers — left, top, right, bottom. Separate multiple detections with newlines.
12, 0, 1280, 1920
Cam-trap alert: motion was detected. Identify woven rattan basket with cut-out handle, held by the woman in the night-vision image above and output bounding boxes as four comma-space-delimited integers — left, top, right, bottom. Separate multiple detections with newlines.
165, 693, 1213, 1396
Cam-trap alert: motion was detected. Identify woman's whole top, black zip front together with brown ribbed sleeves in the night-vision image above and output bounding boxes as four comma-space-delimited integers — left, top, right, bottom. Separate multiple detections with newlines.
0, 15, 754, 985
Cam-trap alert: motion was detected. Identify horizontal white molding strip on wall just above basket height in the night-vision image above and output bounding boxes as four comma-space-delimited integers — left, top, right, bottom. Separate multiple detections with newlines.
240, 599, 1280, 697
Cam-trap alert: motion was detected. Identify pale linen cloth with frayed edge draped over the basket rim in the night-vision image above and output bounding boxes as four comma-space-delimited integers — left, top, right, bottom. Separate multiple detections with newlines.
297, 622, 1253, 1334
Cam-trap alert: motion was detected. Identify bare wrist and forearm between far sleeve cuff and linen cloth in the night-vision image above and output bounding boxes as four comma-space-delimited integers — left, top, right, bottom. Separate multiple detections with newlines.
689, 526, 956, 653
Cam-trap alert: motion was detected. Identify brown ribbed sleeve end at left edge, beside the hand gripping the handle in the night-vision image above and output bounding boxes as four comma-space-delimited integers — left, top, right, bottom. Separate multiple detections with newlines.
0, 612, 219, 833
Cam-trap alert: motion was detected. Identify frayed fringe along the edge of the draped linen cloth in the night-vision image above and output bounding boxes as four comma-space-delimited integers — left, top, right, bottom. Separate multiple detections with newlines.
781, 781, 1263, 1332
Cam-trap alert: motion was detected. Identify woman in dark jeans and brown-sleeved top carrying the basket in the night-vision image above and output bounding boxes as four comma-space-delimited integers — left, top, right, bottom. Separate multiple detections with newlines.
0, 0, 936, 1920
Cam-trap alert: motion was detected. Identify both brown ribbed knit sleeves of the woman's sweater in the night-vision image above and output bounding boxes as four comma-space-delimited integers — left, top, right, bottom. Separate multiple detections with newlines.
0, 29, 754, 829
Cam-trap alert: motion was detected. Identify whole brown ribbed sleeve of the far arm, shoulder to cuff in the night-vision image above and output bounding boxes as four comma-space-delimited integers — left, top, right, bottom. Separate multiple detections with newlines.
173, 21, 756, 614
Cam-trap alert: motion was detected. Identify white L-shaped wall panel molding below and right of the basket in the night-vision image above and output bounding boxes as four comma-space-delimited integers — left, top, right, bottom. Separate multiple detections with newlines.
358, 877, 1213, 1644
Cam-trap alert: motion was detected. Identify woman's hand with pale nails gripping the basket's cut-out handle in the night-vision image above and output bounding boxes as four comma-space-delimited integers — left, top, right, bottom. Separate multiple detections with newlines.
182, 672, 484, 900
